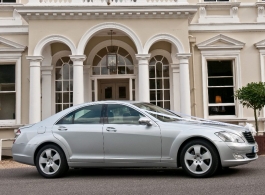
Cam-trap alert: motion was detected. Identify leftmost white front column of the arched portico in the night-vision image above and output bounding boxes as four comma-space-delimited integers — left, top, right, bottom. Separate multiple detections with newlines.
27, 56, 43, 124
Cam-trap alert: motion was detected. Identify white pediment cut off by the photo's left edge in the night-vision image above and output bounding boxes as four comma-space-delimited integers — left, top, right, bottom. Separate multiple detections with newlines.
0, 37, 26, 52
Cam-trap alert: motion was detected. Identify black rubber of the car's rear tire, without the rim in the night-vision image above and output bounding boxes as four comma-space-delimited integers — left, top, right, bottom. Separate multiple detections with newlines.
35, 144, 69, 178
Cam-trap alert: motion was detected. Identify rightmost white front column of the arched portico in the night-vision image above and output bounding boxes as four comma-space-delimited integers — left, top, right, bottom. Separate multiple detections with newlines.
176, 53, 191, 115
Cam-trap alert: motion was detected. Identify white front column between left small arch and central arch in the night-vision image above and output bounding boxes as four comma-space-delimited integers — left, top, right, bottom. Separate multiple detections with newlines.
70, 55, 86, 105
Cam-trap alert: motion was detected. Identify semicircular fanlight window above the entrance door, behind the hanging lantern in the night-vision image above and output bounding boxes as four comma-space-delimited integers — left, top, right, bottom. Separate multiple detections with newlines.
93, 46, 134, 75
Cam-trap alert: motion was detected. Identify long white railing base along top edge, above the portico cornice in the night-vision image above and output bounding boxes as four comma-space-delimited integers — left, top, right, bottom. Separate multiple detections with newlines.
27, 0, 182, 6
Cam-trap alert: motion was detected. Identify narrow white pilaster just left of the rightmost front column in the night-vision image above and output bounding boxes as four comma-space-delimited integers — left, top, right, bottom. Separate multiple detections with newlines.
171, 64, 180, 112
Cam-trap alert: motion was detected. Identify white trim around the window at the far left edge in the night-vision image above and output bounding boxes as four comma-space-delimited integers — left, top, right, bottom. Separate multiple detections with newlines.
0, 53, 22, 126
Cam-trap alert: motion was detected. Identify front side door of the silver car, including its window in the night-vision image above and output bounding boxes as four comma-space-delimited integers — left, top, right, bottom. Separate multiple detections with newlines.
103, 103, 161, 163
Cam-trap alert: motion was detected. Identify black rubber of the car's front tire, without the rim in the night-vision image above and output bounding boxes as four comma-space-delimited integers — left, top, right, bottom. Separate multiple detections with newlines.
180, 139, 219, 178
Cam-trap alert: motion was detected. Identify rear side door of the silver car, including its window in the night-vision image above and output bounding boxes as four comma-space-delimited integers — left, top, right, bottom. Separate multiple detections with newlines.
53, 104, 104, 162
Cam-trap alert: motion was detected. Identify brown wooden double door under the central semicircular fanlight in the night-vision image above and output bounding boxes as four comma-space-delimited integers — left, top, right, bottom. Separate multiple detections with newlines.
98, 79, 130, 100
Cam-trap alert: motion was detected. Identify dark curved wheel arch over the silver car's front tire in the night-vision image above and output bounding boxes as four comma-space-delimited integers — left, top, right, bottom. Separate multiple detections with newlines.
176, 136, 221, 167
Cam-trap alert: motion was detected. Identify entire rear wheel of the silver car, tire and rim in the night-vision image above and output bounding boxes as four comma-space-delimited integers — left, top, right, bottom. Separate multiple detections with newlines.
35, 144, 69, 178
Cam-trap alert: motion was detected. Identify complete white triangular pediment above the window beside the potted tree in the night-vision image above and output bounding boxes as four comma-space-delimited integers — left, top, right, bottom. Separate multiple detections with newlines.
197, 34, 245, 50
